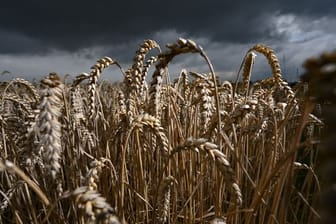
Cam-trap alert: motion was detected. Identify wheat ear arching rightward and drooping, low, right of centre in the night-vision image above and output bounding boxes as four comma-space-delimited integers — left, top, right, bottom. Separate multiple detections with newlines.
170, 138, 243, 205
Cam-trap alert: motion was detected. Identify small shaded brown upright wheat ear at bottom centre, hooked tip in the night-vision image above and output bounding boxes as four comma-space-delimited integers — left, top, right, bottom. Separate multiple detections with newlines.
156, 176, 177, 223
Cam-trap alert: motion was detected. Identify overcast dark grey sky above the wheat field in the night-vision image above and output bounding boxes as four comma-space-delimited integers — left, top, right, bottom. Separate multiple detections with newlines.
0, 0, 336, 81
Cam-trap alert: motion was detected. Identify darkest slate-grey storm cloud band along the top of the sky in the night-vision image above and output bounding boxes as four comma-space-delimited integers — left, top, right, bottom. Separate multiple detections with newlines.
0, 0, 334, 53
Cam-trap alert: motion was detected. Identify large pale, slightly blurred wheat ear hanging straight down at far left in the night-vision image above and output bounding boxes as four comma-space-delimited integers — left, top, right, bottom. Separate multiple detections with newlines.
35, 73, 63, 178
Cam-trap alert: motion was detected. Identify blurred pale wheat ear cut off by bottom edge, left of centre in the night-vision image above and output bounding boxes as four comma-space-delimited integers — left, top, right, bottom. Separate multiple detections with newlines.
63, 186, 120, 224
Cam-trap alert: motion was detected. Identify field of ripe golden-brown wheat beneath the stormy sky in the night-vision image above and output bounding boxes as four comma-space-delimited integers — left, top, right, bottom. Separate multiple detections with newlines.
0, 38, 330, 224
